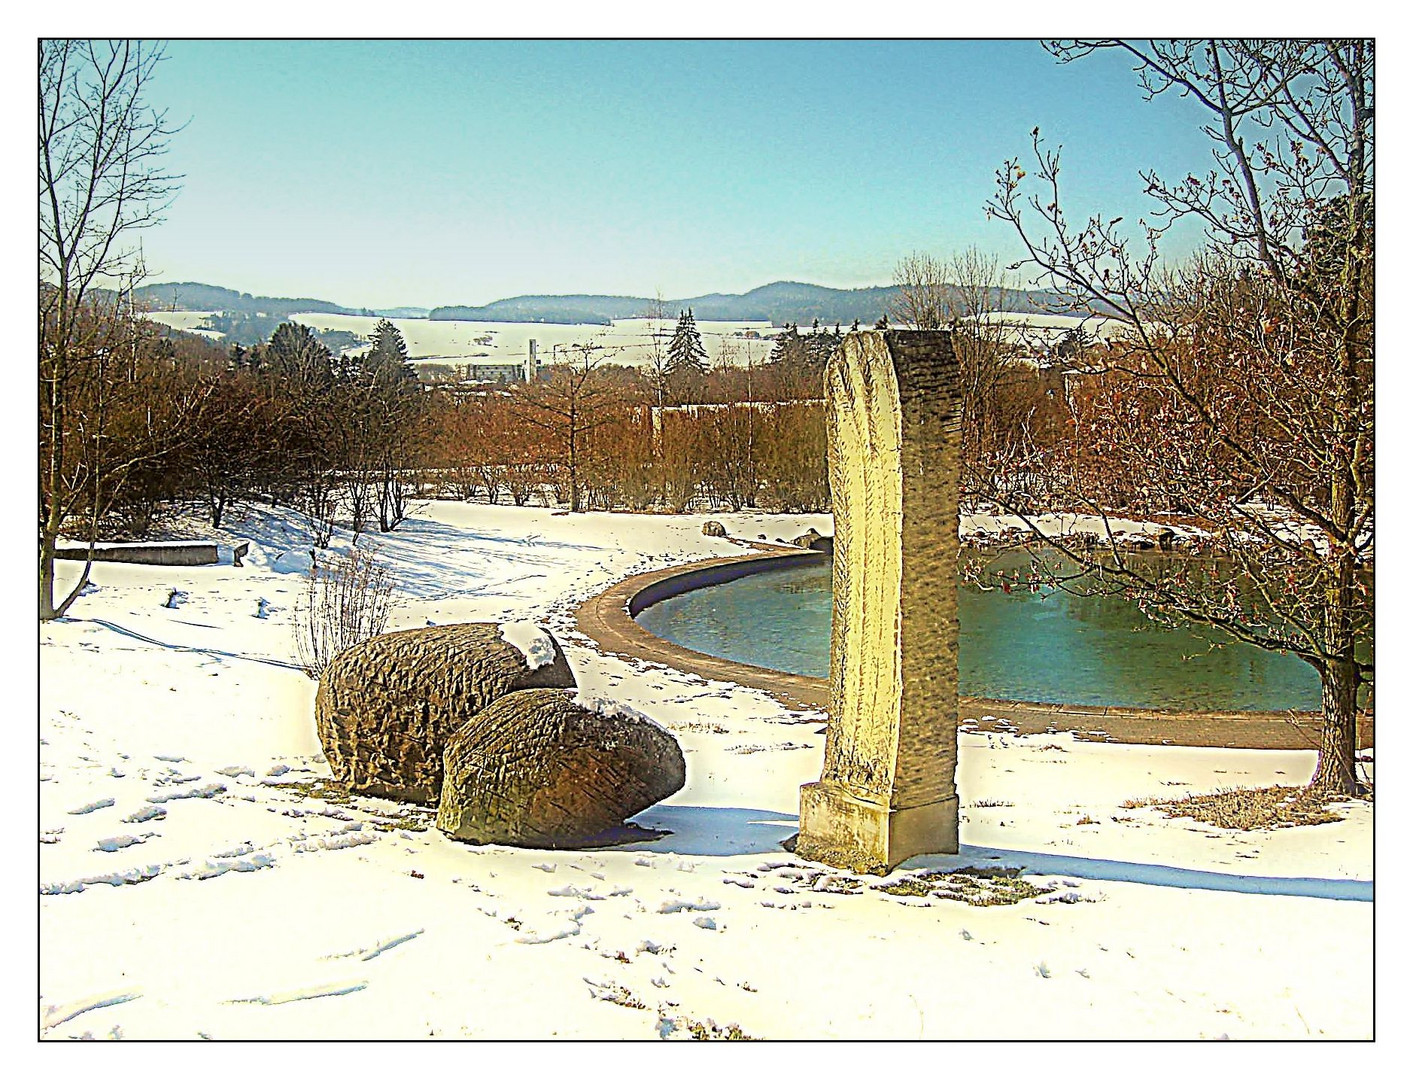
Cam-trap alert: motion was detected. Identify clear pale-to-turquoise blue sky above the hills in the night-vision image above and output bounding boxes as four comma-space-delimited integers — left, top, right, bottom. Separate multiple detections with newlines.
143, 41, 1210, 307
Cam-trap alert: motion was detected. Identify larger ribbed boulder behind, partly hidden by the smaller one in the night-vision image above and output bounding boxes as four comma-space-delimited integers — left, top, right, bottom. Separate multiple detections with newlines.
314, 622, 575, 803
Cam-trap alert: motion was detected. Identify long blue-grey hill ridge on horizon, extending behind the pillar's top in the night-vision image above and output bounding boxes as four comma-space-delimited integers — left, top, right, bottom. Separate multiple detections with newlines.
428, 281, 1057, 327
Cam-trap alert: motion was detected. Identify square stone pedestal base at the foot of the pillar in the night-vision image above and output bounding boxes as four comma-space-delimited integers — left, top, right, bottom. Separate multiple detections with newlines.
796, 780, 959, 874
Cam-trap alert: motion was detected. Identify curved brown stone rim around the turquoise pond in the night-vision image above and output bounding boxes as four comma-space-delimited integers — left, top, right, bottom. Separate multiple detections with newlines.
575, 548, 1373, 751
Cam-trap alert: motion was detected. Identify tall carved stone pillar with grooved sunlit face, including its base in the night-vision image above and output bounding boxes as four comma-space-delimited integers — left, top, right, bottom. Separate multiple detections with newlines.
796, 331, 961, 874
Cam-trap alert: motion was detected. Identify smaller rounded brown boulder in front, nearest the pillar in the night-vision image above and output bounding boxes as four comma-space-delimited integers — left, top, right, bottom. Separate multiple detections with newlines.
437, 690, 687, 847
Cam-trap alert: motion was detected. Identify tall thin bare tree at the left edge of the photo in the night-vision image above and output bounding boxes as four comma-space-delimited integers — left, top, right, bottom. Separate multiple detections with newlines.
40, 41, 177, 619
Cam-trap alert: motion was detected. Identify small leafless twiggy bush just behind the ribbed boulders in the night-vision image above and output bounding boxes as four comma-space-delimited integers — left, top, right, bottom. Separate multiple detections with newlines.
294, 547, 396, 679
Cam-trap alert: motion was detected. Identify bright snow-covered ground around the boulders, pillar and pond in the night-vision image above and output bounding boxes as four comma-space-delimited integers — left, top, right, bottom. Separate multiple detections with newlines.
38, 502, 1373, 1040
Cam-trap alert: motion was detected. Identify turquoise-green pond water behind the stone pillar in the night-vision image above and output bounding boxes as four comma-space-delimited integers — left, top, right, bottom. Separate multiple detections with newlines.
637, 563, 1320, 710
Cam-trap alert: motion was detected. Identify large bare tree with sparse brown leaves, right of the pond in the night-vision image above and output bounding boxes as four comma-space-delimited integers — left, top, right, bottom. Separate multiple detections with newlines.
988, 40, 1373, 793
